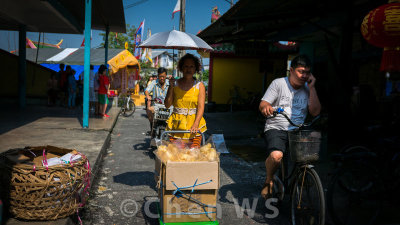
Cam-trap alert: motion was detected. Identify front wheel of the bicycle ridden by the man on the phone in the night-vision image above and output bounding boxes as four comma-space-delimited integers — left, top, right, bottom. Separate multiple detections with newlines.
291, 167, 325, 225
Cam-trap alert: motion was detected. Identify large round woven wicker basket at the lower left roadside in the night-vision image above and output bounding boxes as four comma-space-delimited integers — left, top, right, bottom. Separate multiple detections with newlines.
0, 146, 90, 220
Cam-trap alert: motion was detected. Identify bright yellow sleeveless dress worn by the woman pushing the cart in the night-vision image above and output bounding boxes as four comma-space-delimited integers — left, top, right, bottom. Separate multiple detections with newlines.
165, 82, 207, 139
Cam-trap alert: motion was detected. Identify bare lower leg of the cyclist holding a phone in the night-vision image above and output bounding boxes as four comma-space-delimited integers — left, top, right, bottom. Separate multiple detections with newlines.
261, 151, 283, 198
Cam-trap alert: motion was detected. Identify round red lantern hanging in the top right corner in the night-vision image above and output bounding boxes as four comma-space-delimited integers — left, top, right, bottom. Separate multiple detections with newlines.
361, 3, 400, 71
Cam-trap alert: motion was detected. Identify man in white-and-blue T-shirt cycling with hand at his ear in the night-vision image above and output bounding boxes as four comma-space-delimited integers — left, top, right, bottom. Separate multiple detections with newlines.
259, 55, 321, 199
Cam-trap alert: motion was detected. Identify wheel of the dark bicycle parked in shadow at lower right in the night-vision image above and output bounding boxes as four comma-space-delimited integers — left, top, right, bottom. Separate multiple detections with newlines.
327, 163, 382, 225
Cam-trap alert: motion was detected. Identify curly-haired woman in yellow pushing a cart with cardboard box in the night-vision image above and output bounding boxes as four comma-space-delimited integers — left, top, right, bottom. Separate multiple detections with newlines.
165, 53, 207, 147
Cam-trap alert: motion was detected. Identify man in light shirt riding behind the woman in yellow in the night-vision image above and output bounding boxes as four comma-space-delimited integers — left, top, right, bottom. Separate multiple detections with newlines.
144, 67, 169, 131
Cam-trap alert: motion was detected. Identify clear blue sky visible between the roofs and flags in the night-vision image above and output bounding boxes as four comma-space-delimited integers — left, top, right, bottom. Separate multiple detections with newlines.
0, 0, 237, 65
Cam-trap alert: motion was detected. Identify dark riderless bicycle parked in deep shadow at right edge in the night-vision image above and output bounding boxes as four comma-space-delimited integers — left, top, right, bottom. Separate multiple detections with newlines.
327, 135, 400, 225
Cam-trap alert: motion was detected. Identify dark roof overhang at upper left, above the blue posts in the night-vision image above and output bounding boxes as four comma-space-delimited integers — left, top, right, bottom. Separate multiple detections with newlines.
0, 0, 126, 34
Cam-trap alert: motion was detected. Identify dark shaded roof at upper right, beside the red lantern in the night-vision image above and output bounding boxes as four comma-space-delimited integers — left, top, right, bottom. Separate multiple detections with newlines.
197, 0, 387, 44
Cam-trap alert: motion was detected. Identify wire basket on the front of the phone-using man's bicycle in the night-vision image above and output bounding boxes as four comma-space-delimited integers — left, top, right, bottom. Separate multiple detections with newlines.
289, 130, 321, 162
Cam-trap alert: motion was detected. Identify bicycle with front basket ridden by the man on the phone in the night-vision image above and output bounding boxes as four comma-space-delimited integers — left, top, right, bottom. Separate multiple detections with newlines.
267, 108, 325, 225
